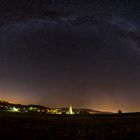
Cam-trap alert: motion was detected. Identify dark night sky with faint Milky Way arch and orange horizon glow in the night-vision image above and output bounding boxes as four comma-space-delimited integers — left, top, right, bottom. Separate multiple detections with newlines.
0, 0, 140, 112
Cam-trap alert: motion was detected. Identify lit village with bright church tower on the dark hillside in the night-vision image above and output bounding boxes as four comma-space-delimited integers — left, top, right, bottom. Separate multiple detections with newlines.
0, 101, 99, 115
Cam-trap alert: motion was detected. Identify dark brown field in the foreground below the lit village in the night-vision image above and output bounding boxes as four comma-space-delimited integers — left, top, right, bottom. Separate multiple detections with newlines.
0, 112, 140, 140
